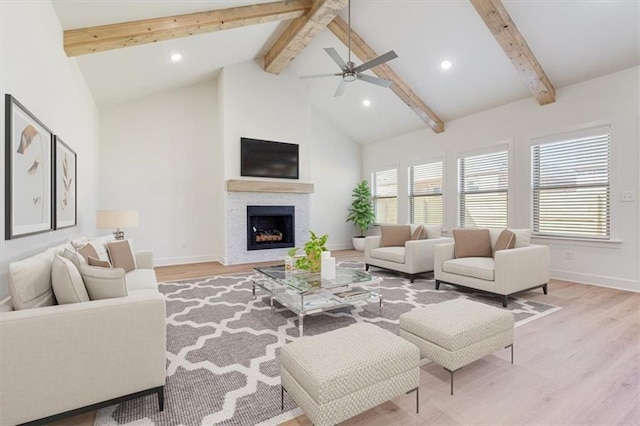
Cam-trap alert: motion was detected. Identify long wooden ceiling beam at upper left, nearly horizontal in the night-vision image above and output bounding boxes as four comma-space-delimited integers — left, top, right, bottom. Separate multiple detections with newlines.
64, 0, 313, 56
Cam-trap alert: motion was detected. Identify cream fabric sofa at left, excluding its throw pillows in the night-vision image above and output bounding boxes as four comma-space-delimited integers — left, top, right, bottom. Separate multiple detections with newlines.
0, 238, 166, 425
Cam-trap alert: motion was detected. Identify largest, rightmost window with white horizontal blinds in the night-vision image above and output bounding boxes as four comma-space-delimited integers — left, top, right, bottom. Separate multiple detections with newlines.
531, 128, 611, 239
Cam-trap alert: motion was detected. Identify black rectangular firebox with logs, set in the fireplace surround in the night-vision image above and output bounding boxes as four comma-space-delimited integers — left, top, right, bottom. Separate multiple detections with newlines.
247, 206, 296, 250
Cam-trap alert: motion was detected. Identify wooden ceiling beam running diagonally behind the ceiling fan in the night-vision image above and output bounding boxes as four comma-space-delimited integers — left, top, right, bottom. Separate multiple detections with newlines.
328, 16, 444, 133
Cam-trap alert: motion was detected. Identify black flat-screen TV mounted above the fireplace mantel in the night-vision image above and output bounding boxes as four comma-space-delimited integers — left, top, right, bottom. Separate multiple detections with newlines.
240, 138, 299, 179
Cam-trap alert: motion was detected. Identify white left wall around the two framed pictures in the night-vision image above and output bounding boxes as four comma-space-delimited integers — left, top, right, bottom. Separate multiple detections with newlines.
0, 1, 99, 299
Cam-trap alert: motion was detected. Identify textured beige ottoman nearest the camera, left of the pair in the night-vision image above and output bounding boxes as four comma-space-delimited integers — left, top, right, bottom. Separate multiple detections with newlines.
280, 324, 420, 425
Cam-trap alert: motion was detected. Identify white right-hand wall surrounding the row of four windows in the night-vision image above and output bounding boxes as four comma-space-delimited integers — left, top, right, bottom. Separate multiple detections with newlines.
363, 68, 640, 291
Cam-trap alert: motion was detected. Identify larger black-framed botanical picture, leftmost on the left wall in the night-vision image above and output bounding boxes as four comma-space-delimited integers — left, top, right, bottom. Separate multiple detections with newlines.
5, 94, 53, 240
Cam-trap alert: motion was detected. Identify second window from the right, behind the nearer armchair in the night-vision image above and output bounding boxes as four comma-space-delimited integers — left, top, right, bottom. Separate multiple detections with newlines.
458, 150, 509, 228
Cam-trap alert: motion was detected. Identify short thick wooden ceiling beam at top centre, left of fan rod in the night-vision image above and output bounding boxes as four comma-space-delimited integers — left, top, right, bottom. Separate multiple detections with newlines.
264, 0, 347, 74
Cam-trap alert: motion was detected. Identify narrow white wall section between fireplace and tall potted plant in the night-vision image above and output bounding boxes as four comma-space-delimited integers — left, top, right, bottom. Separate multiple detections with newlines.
311, 110, 362, 250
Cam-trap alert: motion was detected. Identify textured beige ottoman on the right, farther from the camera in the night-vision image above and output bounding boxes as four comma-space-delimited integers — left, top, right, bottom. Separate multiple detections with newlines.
400, 299, 515, 395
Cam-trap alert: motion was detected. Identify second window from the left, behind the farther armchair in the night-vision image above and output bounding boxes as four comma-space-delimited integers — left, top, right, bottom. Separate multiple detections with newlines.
409, 161, 443, 225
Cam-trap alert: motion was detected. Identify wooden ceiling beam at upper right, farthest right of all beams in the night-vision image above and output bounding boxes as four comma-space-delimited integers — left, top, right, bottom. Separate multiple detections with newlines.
470, 0, 556, 105
